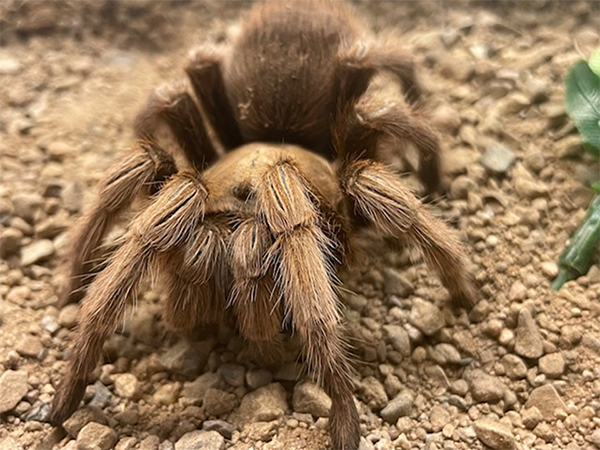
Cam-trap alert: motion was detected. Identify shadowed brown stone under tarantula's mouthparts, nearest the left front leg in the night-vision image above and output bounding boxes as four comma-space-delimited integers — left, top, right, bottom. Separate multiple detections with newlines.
160, 339, 215, 378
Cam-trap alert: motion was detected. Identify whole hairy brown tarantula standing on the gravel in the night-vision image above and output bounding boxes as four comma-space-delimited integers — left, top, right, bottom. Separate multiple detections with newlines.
51, 0, 476, 450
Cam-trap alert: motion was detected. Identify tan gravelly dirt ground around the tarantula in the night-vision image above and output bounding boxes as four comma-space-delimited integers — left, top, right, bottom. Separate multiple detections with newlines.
0, 0, 600, 450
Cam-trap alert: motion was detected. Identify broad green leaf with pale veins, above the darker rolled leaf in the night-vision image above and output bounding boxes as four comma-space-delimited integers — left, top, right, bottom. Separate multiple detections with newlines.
565, 61, 600, 157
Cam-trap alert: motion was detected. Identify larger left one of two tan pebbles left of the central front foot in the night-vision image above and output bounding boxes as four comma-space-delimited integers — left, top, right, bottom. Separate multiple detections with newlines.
235, 383, 288, 424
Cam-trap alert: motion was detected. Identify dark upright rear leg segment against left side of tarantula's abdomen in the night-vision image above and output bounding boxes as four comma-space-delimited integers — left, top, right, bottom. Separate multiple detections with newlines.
185, 48, 243, 150
